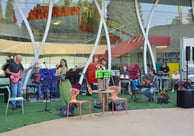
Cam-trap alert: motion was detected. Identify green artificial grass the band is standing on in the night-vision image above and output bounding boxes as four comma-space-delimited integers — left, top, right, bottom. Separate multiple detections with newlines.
0, 91, 176, 133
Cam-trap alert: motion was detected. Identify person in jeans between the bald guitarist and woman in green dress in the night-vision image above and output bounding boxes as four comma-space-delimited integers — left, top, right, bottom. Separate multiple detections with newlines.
31, 67, 43, 99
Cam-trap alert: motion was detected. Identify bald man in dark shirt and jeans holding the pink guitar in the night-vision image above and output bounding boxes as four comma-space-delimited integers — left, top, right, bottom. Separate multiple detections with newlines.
5, 55, 24, 110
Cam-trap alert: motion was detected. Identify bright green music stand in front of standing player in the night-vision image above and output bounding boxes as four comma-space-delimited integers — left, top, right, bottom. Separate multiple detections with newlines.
95, 70, 111, 91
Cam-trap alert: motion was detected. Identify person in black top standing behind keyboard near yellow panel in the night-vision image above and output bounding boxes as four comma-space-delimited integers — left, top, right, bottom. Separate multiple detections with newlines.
160, 63, 170, 90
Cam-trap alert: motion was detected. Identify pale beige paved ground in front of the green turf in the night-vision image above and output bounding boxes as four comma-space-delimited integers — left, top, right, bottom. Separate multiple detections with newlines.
0, 108, 194, 136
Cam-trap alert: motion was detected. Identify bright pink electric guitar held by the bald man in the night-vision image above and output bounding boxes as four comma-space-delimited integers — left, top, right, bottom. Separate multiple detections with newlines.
10, 63, 38, 84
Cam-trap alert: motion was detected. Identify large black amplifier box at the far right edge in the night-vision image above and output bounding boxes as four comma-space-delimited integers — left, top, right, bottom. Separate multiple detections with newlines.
177, 89, 194, 108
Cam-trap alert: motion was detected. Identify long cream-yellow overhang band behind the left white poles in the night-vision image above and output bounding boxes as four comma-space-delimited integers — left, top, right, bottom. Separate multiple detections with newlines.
0, 39, 107, 56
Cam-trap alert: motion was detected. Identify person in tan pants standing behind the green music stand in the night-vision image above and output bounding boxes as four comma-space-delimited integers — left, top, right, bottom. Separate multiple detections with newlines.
95, 58, 109, 108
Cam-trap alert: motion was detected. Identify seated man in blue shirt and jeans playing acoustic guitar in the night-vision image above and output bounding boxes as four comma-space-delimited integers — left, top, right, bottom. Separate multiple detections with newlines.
141, 69, 158, 101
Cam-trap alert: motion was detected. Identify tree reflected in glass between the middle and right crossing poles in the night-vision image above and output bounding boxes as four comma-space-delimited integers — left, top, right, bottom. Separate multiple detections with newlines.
107, 0, 141, 36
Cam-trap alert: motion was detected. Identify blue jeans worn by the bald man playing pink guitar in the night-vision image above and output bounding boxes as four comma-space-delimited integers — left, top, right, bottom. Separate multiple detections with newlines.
11, 80, 22, 107
